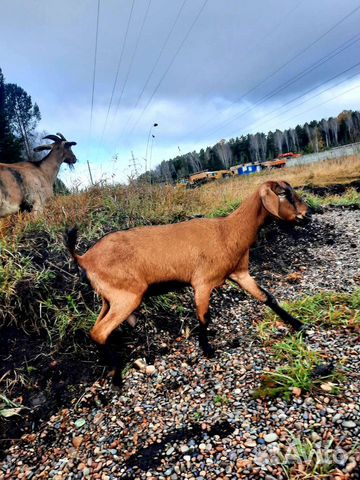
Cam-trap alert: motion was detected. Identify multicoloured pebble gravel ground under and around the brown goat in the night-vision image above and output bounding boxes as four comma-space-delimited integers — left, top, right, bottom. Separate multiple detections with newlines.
0, 209, 360, 480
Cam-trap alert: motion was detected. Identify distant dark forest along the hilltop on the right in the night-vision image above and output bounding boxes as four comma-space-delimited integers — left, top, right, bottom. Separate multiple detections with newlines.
143, 110, 360, 183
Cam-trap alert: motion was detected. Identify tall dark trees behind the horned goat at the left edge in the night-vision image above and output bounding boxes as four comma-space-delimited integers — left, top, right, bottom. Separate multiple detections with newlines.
0, 68, 41, 163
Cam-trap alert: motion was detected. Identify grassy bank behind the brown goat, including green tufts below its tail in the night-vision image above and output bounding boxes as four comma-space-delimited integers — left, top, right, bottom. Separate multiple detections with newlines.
0, 157, 360, 358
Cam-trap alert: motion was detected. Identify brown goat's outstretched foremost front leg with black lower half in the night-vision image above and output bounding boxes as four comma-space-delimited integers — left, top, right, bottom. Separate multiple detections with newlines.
230, 271, 304, 331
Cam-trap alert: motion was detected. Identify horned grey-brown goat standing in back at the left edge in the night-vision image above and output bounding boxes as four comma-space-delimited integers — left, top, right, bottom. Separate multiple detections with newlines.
0, 133, 76, 217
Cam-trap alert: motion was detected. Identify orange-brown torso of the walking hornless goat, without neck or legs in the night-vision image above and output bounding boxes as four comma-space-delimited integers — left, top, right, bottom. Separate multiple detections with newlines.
78, 219, 232, 285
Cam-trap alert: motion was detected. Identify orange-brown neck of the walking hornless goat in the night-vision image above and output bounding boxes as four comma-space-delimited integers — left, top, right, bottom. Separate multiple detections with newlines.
225, 192, 269, 254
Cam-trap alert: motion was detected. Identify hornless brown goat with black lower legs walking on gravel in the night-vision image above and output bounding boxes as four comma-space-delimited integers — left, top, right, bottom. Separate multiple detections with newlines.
65, 181, 308, 356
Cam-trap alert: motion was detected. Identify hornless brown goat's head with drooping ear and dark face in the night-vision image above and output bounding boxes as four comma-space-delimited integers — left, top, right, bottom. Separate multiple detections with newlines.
259, 181, 310, 222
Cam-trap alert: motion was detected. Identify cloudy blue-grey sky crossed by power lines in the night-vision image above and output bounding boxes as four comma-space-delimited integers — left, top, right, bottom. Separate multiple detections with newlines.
0, 0, 360, 187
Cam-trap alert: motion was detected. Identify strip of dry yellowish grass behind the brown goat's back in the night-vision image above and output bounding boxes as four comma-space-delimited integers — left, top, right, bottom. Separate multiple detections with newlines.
0, 156, 360, 241
